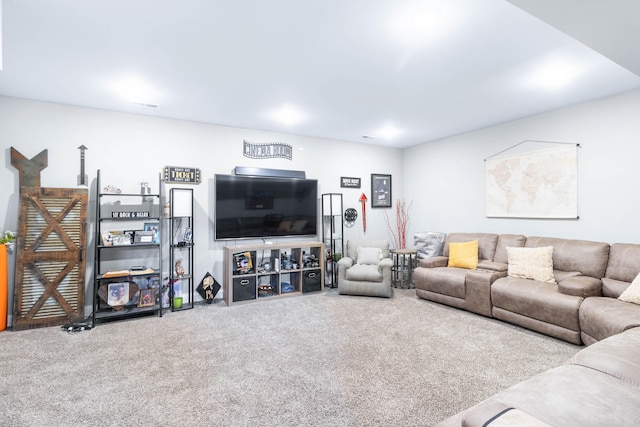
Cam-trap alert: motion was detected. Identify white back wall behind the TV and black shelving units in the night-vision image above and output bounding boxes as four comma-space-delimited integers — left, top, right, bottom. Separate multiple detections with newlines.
0, 97, 402, 314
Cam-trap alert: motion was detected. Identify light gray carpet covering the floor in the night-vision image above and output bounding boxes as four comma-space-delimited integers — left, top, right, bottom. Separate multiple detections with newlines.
0, 289, 579, 427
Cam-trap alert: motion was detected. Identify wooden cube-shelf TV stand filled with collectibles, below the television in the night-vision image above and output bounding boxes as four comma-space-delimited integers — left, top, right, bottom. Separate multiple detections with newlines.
224, 242, 324, 306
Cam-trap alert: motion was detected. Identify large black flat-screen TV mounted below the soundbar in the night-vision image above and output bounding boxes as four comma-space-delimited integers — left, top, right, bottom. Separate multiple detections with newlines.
215, 175, 318, 240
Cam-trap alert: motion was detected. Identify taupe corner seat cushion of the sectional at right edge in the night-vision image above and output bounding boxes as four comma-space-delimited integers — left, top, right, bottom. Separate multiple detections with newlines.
579, 297, 640, 345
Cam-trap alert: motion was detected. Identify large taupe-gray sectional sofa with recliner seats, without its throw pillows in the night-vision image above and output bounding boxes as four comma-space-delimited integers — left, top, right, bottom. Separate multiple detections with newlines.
414, 233, 640, 427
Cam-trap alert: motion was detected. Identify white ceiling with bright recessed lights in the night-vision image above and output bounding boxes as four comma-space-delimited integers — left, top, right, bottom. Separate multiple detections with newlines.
0, 0, 640, 147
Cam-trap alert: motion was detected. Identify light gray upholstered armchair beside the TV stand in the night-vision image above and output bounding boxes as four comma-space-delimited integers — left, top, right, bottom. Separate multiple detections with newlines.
338, 240, 393, 298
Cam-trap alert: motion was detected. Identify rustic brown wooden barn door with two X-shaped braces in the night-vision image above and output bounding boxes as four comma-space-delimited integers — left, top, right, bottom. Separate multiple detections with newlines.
13, 186, 88, 330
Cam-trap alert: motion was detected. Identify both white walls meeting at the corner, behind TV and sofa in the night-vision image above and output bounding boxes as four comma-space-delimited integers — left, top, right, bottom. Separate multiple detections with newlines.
7, 91, 640, 324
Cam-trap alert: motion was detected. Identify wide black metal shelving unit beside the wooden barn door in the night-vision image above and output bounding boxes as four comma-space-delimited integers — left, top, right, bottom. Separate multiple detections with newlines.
91, 170, 163, 326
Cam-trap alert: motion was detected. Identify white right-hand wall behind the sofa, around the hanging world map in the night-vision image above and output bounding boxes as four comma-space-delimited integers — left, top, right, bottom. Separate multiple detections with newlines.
403, 91, 640, 243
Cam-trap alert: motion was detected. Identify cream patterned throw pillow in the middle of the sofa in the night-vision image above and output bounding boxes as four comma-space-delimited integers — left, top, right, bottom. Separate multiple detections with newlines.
507, 246, 556, 283
